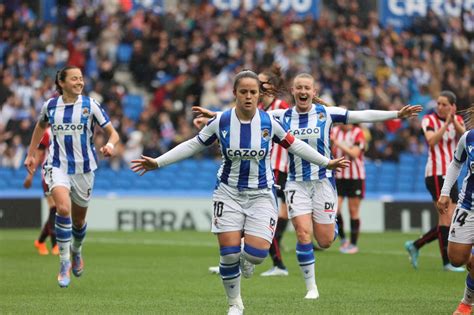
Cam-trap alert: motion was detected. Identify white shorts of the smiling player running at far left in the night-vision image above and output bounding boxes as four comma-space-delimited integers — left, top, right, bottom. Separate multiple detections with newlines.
44, 166, 95, 207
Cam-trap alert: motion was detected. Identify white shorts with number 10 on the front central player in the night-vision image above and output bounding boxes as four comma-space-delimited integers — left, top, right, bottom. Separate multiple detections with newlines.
211, 183, 278, 243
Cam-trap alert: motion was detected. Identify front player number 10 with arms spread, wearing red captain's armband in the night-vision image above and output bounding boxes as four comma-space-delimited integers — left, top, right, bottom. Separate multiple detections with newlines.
132, 70, 348, 314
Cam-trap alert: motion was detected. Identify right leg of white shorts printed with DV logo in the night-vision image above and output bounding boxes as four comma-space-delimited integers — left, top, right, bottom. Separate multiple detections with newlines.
311, 178, 338, 224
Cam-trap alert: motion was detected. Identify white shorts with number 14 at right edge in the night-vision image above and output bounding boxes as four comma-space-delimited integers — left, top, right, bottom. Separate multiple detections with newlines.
448, 208, 474, 244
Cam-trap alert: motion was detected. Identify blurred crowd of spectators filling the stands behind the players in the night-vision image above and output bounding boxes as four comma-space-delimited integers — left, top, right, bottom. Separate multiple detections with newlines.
0, 0, 474, 168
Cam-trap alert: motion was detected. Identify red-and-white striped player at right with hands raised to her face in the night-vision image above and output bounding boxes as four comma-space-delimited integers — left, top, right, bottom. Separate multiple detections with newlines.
405, 91, 466, 272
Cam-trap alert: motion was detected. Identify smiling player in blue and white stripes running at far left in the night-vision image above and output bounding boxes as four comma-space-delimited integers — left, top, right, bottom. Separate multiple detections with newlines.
25, 66, 119, 288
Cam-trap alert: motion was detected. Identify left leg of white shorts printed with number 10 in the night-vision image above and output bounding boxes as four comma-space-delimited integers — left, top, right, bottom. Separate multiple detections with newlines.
211, 183, 245, 233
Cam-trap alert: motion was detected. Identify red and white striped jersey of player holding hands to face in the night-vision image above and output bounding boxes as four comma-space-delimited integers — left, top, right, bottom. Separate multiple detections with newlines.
421, 113, 464, 177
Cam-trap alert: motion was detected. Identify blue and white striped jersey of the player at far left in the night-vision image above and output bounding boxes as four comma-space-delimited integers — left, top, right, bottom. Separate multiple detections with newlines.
39, 95, 110, 174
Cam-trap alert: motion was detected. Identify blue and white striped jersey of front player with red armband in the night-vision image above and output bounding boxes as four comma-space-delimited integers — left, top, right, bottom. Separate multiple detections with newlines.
197, 108, 294, 189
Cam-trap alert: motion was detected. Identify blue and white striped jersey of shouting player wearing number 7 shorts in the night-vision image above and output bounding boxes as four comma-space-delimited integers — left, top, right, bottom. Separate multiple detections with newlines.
271, 104, 348, 181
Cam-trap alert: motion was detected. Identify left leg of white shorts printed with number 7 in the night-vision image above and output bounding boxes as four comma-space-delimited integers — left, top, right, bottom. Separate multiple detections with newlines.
285, 181, 313, 219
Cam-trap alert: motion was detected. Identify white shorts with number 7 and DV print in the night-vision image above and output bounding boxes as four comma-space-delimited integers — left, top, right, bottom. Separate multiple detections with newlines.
285, 178, 337, 224
